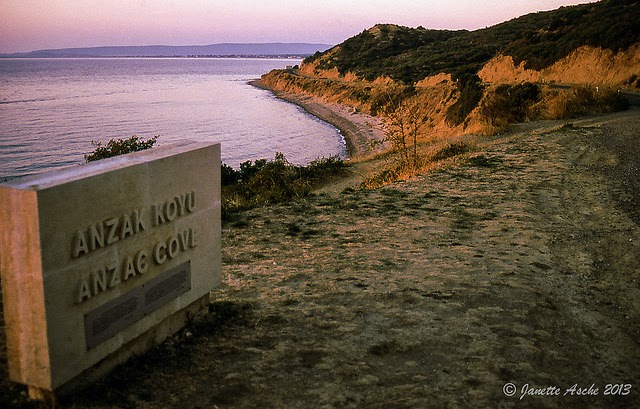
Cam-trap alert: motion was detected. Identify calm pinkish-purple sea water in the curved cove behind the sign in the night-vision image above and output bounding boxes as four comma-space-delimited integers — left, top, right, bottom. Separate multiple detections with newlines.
0, 58, 345, 181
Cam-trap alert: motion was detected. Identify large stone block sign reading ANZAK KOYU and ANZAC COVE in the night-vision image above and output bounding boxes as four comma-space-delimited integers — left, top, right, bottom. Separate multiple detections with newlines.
0, 143, 220, 390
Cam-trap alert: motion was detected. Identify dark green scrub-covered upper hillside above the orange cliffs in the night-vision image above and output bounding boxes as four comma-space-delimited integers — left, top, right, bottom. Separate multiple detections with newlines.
305, 0, 640, 84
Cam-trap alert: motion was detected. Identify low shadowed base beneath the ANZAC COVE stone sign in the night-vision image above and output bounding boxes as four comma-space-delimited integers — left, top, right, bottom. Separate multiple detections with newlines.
28, 294, 210, 400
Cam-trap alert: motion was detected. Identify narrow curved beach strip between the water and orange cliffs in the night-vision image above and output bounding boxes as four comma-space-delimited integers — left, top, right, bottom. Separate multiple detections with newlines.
248, 79, 387, 160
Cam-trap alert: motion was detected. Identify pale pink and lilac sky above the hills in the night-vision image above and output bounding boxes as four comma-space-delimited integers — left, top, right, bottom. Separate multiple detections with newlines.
0, 0, 589, 53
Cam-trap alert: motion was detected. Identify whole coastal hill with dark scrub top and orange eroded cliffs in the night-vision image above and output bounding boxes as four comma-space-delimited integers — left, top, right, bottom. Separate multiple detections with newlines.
261, 0, 640, 186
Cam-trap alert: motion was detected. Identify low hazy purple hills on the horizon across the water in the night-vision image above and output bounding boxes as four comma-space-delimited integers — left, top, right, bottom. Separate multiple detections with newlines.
2, 43, 331, 58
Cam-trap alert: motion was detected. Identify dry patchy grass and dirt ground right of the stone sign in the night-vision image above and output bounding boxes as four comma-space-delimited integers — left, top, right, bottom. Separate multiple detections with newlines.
2, 111, 640, 409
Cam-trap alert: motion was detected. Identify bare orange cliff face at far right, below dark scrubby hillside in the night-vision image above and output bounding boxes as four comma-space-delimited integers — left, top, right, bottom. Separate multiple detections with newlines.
478, 45, 640, 87
